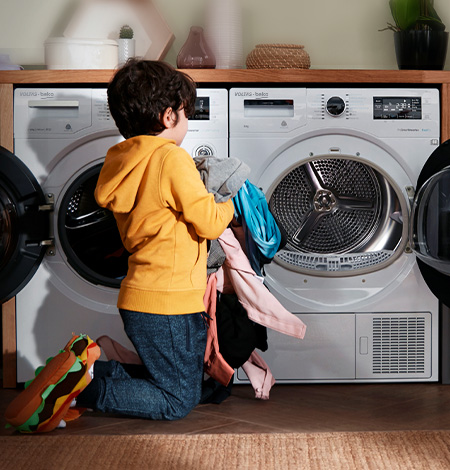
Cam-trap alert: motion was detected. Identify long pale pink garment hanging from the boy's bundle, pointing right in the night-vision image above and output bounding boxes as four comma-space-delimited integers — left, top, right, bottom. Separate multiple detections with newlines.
216, 228, 306, 339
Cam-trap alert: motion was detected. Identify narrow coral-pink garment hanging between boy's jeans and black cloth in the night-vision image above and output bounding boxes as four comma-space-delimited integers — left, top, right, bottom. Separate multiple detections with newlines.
203, 273, 234, 387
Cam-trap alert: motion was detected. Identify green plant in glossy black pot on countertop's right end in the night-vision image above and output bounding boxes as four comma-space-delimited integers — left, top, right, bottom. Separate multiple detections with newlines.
385, 0, 448, 70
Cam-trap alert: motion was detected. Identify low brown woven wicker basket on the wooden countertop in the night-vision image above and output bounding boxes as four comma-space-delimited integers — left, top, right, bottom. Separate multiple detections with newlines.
246, 44, 311, 69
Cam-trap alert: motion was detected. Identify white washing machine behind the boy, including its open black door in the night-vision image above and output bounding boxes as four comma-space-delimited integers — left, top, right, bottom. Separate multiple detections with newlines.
0, 88, 228, 382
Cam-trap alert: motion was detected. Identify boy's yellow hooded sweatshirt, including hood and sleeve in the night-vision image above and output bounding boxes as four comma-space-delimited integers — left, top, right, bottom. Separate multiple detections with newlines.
95, 136, 234, 314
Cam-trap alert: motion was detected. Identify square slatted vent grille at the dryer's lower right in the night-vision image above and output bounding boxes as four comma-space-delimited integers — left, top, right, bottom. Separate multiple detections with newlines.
373, 317, 425, 374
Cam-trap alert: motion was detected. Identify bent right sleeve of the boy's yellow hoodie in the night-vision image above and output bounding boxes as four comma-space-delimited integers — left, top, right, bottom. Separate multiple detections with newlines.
160, 147, 234, 240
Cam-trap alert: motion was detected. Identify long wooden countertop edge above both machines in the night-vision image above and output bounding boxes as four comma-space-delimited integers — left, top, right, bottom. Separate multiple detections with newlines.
0, 69, 450, 85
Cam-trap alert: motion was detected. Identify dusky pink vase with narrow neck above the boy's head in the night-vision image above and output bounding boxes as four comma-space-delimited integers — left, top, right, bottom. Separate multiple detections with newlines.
177, 26, 216, 69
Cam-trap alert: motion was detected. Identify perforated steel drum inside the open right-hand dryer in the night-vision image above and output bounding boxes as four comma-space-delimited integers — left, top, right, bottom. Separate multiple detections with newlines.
269, 158, 402, 271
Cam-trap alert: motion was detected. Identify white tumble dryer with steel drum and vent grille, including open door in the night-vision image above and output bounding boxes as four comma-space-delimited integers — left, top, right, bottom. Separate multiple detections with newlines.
230, 87, 450, 383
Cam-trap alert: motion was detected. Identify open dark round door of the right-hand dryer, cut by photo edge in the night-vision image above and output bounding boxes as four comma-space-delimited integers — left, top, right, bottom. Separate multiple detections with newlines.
410, 140, 450, 306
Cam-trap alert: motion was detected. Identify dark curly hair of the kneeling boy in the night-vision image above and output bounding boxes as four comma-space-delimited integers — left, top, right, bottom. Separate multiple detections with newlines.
108, 58, 196, 139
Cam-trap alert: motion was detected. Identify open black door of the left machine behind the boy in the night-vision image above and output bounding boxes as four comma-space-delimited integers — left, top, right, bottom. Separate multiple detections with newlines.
0, 147, 50, 303
